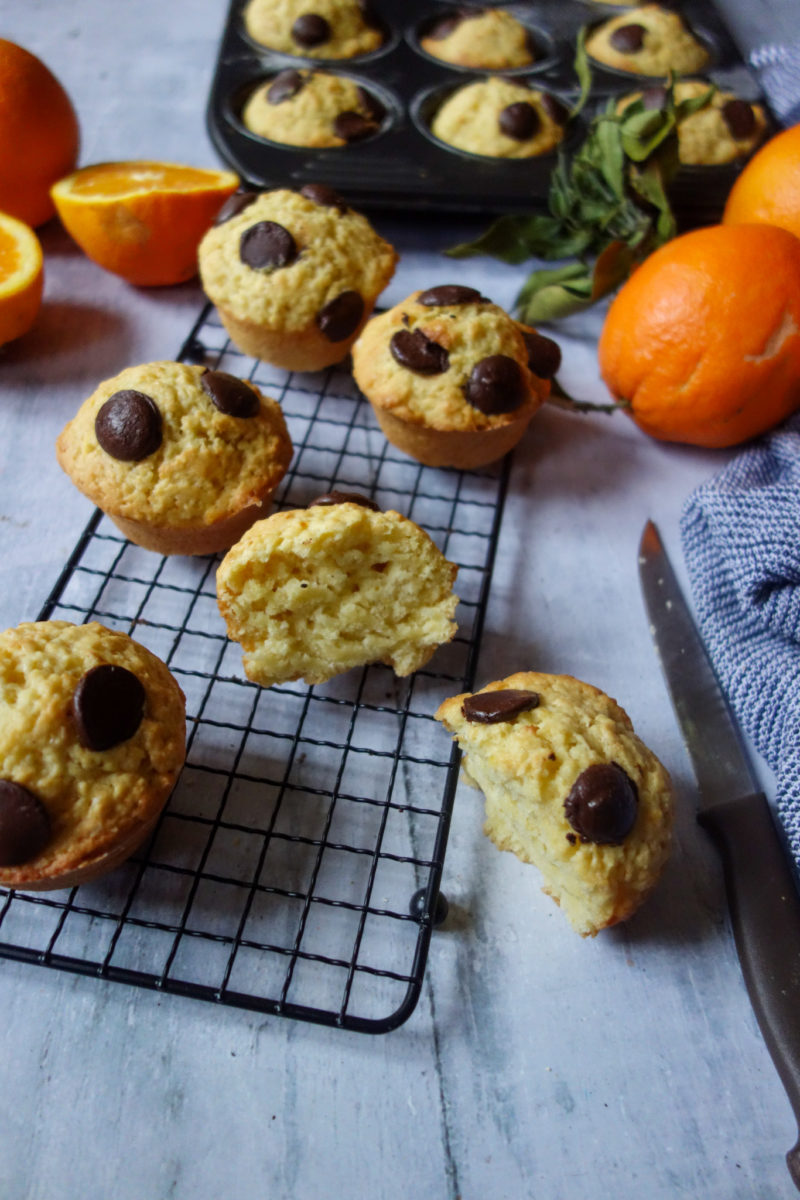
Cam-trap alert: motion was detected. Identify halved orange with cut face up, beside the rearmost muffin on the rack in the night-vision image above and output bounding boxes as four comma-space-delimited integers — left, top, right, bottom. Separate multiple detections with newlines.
50, 161, 239, 287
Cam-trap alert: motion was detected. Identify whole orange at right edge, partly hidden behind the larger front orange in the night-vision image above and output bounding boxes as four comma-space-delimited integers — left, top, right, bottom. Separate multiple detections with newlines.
722, 125, 800, 238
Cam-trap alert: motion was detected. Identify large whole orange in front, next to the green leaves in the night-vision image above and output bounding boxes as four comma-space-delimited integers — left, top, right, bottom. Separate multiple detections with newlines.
597, 224, 800, 446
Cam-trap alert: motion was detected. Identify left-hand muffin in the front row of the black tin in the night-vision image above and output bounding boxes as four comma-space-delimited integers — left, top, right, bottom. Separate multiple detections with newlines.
241, 68, 386, 150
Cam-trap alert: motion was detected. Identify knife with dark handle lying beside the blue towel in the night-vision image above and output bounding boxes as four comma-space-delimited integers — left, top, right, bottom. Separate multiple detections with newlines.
639, 521, 800, 1189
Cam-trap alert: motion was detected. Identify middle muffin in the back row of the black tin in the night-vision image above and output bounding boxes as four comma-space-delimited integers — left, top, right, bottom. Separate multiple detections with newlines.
420, 8, 536, 71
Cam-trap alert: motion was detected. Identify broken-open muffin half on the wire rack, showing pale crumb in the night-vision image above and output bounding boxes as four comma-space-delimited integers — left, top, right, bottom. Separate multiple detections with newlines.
217, 492, 458, 688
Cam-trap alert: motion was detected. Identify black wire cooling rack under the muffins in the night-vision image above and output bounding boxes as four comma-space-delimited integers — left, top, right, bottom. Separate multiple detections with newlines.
0, 306, 509, 1033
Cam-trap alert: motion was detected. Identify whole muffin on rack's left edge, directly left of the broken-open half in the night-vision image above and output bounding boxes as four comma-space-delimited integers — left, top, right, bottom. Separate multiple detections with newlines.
56, 362, 293, 554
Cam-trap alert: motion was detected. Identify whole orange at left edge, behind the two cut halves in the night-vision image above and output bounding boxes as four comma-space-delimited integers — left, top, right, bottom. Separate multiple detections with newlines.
0, 38, 80, 227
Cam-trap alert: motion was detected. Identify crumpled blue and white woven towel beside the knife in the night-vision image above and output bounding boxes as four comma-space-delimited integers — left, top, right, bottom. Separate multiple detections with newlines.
681, 415, 800, 866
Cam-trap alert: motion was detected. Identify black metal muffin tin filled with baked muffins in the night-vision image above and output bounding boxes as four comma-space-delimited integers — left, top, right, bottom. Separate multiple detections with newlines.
207, 0, 763, 224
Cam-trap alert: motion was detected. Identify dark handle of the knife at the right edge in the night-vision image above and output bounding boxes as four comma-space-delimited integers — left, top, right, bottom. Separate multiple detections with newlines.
698, 792, 800, 1188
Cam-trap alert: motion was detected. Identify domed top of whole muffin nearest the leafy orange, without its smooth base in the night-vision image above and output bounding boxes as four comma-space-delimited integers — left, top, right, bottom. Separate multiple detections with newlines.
353, 284, 558, 431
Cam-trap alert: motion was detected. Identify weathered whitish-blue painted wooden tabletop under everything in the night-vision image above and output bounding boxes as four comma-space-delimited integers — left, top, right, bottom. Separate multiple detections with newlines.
0, 0, 796, 1200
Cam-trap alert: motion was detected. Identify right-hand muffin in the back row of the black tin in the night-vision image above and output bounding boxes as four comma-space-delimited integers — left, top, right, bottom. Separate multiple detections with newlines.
587, 4, 709, 76
